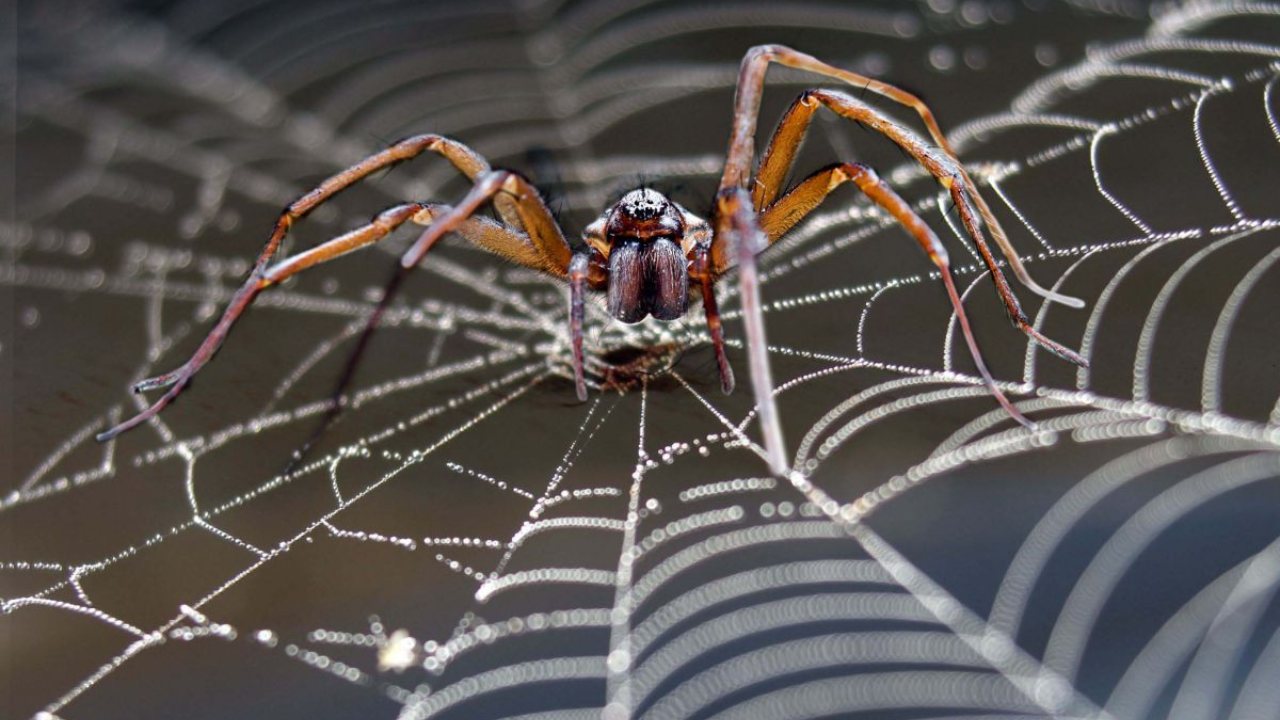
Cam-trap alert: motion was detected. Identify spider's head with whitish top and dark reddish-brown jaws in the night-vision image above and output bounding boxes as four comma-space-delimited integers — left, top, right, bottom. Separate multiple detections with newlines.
604, 188, 689, 323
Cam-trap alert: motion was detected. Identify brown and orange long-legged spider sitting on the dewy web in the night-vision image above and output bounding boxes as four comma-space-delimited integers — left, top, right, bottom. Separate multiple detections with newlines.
97, 45, 1085, 475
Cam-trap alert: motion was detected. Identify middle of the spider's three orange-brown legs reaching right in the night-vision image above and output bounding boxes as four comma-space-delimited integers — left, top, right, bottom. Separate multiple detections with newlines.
754, 90, 1087, 366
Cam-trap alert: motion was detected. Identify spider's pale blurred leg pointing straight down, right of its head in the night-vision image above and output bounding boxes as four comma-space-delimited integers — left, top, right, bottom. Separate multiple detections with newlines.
704, 187, 787, 477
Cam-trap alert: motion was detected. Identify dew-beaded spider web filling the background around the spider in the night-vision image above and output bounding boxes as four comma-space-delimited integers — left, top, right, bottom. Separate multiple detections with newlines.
0, 0, 1280, 717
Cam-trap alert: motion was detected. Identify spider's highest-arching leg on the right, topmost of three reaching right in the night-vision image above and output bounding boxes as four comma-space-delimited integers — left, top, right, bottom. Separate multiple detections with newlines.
721, 45, 1084, 307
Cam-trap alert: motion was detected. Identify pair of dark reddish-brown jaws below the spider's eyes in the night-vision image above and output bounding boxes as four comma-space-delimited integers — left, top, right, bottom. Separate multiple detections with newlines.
608, 237, 689, 323
